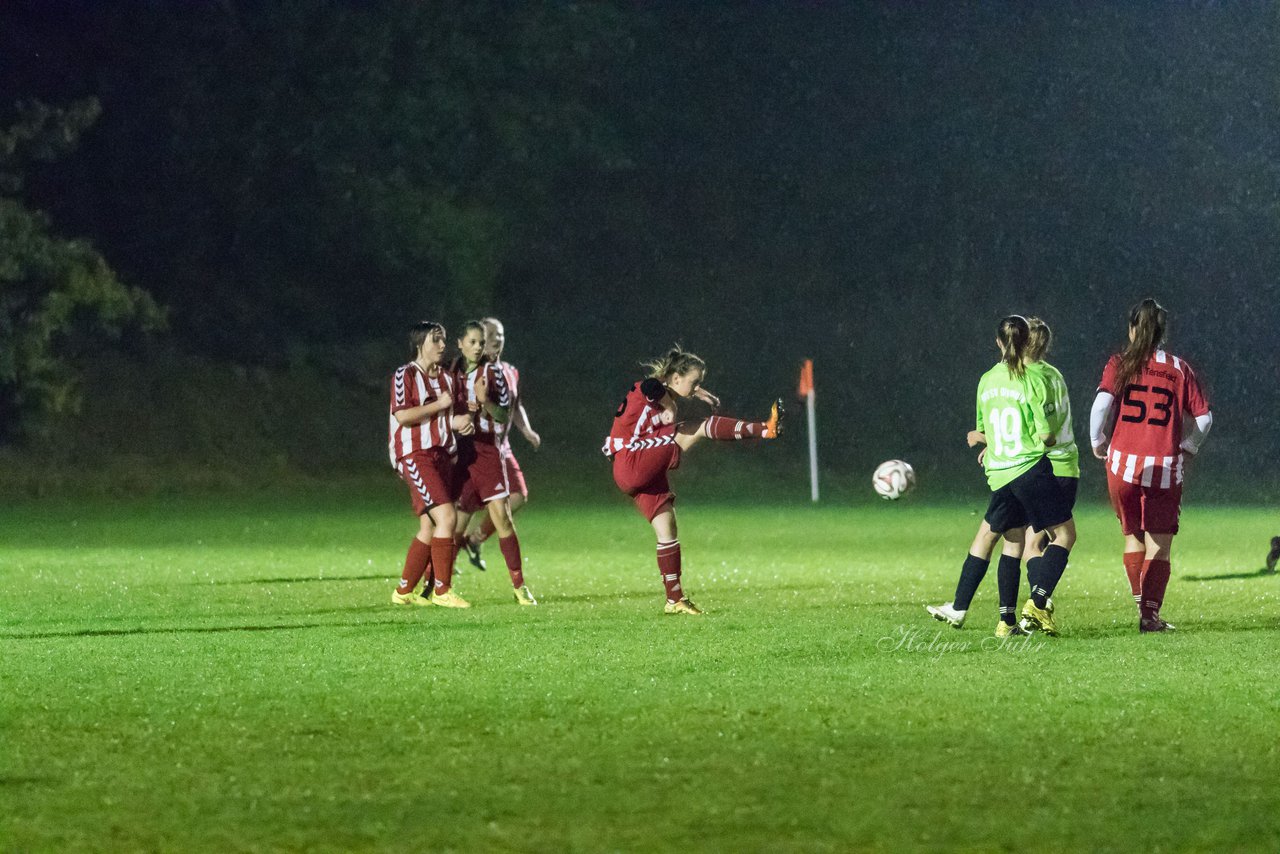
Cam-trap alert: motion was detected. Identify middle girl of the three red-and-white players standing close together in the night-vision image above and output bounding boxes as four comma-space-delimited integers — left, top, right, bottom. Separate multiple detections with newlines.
453, 320, 538, 606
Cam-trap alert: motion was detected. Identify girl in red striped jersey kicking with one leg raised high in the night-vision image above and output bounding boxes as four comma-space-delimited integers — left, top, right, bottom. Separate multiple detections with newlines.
603, 346, 782, 615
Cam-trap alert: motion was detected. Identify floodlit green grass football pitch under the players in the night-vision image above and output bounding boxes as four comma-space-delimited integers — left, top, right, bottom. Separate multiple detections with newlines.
0, 490, 1280, 851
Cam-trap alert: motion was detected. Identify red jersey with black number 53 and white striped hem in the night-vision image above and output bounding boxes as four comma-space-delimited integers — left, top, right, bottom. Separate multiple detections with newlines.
1098, 350, 1208, 489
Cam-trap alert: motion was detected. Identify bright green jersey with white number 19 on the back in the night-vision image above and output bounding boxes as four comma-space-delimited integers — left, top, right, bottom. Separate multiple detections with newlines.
975, 362, 1053, 492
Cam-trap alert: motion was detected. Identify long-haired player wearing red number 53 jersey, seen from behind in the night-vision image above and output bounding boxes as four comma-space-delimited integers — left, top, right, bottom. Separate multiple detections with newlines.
1089, 298, 1213, 631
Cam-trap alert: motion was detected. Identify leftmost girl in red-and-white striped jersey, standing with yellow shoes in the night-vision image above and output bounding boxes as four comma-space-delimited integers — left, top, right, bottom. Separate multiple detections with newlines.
388, 320, 475, 608
